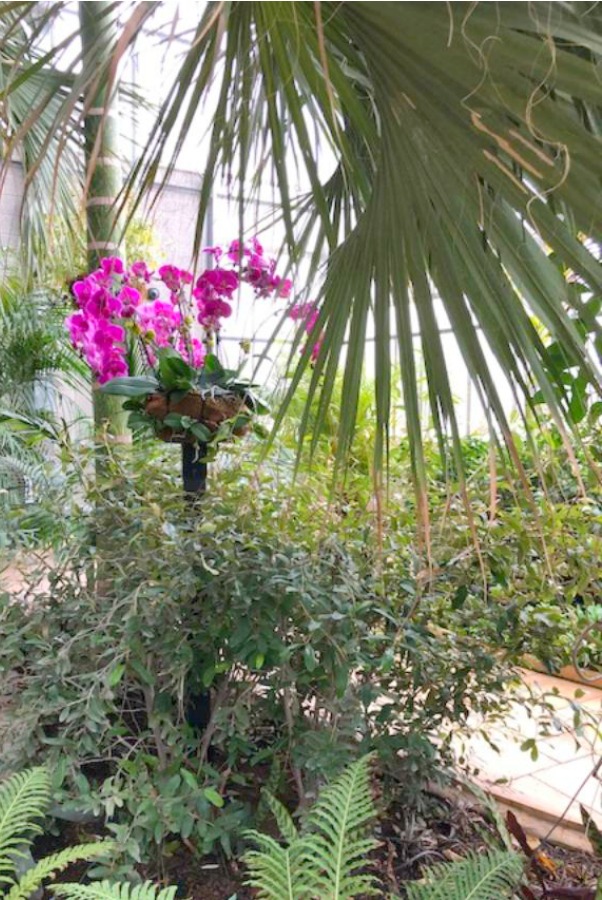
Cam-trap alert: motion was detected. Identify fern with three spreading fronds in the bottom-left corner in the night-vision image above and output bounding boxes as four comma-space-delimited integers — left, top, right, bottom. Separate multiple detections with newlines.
0, 767, 176, 900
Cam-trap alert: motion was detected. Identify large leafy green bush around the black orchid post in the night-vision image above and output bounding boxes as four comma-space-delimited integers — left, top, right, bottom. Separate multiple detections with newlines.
0, 444, 505, 875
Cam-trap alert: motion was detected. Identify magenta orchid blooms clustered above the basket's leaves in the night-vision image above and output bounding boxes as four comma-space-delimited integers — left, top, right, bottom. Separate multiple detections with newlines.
65, 238, 296, 384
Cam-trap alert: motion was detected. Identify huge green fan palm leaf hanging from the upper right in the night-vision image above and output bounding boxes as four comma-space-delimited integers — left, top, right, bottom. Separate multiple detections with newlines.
1, 2, 602, 492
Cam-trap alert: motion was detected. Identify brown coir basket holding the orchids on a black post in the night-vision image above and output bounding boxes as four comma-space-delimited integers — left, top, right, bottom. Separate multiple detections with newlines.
145, 392, 251, 444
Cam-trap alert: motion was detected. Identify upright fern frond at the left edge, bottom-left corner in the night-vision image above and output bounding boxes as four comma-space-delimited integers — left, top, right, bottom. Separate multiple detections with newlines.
0, 767, 50, 884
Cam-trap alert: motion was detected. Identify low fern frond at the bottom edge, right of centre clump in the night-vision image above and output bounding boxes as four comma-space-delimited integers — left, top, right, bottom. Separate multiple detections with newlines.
407, 850, 523, 900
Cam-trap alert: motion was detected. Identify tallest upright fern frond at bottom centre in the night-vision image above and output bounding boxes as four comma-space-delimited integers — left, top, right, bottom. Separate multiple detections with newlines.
307, 757, 378, 900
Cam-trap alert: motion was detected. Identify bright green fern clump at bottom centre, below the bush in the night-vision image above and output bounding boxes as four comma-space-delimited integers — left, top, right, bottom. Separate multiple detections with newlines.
243, 757, 378, 900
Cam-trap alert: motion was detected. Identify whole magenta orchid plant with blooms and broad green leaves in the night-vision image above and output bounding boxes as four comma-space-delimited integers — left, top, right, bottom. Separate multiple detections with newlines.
66, 238, 319, 442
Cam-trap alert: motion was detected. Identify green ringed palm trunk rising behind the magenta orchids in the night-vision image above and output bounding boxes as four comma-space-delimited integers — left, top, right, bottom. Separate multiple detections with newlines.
79, 0, 130, 443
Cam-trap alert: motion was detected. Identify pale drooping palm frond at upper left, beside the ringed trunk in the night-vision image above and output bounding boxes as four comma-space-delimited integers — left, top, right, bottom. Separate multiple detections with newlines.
0, 2, 157, 268
